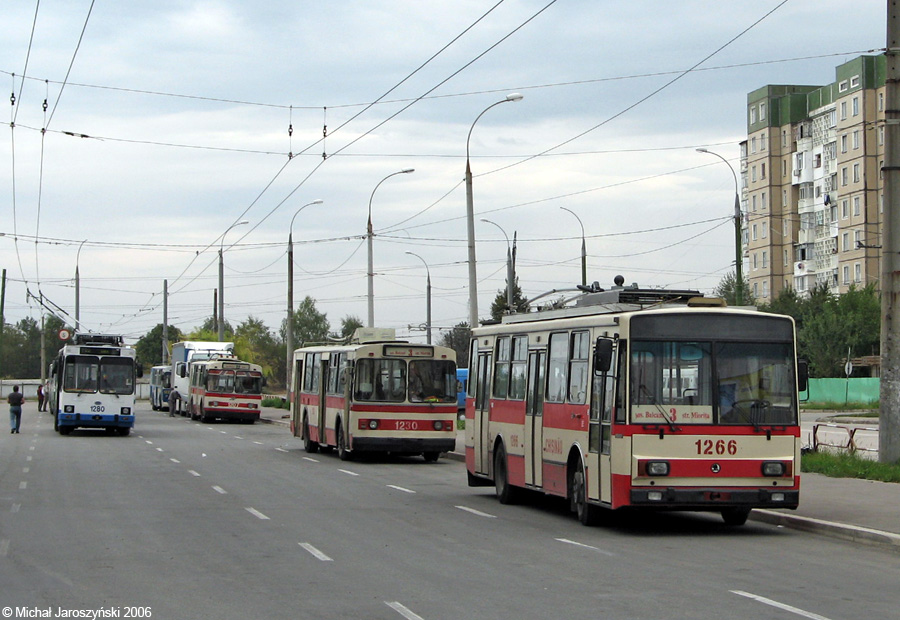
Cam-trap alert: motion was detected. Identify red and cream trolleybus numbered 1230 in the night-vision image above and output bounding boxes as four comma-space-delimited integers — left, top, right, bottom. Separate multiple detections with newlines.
290, 328, 457, 462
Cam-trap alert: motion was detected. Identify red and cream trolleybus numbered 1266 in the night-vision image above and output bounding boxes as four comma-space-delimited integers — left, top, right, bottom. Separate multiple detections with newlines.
465, 277, 806, 525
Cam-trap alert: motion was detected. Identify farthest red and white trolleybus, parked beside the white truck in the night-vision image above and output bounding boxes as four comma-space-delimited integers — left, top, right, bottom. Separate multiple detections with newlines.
186, 355, 263, 424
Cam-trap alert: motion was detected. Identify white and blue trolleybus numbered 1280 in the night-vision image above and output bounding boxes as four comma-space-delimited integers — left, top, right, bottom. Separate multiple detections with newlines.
47, 334, 142, 435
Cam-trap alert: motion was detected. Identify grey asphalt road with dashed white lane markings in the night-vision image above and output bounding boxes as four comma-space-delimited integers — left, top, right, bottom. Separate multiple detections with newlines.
0, 409, 900, 620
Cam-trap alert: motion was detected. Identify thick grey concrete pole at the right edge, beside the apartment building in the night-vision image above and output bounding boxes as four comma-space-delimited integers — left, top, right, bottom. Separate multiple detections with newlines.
878, 0, 900, 463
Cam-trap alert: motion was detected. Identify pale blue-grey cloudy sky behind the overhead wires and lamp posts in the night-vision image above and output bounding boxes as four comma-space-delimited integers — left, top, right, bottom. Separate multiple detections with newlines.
0, 0, 886, 340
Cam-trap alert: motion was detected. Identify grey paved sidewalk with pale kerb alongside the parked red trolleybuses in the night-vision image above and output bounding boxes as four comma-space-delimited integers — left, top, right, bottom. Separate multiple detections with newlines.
260, 407, 900, 553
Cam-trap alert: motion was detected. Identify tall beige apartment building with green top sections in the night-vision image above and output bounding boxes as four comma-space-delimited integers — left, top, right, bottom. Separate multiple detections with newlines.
741, 55, 885, 302
